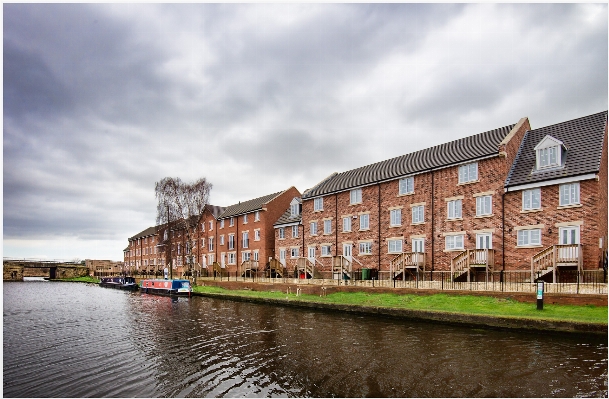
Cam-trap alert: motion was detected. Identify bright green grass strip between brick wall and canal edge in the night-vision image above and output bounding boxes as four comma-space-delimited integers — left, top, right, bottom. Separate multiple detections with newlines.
194, 286, 607, 324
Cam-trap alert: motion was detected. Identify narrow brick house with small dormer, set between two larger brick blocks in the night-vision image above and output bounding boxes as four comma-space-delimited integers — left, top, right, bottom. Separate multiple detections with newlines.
273, 197, 306, 276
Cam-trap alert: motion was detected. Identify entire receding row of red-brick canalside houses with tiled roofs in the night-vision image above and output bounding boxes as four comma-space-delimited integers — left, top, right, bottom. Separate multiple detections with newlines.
125, 111, 608, 281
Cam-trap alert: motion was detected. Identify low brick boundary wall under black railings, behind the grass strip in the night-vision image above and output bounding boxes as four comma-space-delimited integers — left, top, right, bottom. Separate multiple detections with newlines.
198, 280, 608, 306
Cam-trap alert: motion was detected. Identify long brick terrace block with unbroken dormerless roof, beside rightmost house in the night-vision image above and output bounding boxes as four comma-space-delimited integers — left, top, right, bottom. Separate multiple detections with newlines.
302, 118, 530, 279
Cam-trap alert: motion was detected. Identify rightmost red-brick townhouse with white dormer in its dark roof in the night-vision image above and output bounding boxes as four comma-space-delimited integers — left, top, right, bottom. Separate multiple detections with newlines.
505, 111, 608, 281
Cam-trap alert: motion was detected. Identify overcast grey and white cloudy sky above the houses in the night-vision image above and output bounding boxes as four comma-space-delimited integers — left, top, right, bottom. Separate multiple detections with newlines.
3, 3, 608, 260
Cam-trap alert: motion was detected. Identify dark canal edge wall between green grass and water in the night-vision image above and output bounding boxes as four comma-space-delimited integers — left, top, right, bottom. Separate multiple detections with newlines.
192, 292, 608, 335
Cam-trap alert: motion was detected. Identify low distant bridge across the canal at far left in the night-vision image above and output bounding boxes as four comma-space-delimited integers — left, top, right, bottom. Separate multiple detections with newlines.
2, 258, 89, 281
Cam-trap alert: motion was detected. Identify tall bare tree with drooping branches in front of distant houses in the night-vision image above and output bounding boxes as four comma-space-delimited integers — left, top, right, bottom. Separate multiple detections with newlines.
154, 177, 212, 278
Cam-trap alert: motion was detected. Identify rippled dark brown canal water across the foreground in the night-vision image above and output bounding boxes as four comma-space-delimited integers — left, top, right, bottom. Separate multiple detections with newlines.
3, 282, 607, 398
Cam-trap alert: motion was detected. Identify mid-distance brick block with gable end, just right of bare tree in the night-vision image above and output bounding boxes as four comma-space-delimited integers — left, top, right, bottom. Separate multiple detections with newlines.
214, 187, 300, 276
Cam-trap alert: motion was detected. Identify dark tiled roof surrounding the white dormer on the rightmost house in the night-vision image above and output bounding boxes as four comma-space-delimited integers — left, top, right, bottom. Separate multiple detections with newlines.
505, 111, 607, 187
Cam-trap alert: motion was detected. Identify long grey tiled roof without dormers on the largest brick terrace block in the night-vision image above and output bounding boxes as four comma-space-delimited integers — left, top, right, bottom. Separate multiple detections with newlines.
302, 125, 515, 199
